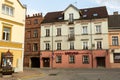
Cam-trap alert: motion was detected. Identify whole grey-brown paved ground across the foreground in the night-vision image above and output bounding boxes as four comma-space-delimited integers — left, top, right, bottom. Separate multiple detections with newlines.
0, 68, 120, 80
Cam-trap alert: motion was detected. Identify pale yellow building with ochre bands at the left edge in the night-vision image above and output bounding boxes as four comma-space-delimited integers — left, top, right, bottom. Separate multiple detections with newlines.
0, 0, 26, 72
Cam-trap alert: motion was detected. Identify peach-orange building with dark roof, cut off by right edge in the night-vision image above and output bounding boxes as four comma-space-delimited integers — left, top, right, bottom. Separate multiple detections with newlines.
108, 12, 120, 68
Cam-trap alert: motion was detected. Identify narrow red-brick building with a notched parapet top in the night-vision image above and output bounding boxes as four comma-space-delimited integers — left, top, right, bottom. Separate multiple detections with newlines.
24, 13, 43, 67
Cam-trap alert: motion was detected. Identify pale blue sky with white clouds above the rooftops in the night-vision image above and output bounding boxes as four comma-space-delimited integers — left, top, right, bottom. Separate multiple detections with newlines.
20, 0, 120, 15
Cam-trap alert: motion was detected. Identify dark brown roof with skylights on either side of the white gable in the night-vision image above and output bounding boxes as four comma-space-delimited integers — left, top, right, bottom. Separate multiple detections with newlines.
42, 5, 108, 23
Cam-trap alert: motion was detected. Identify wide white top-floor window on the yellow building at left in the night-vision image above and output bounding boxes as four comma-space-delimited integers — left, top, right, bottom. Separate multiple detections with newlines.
2, 4, 14, 16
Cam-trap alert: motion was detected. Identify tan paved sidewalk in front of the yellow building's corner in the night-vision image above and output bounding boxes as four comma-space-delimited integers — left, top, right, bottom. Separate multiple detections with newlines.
0, 68, 45, 80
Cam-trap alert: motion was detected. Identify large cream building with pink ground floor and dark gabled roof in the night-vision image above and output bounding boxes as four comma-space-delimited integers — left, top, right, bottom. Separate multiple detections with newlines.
40, 5, 109, 68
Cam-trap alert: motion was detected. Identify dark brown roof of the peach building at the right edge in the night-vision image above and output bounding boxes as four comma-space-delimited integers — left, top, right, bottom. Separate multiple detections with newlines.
108, 14, 120, 29
